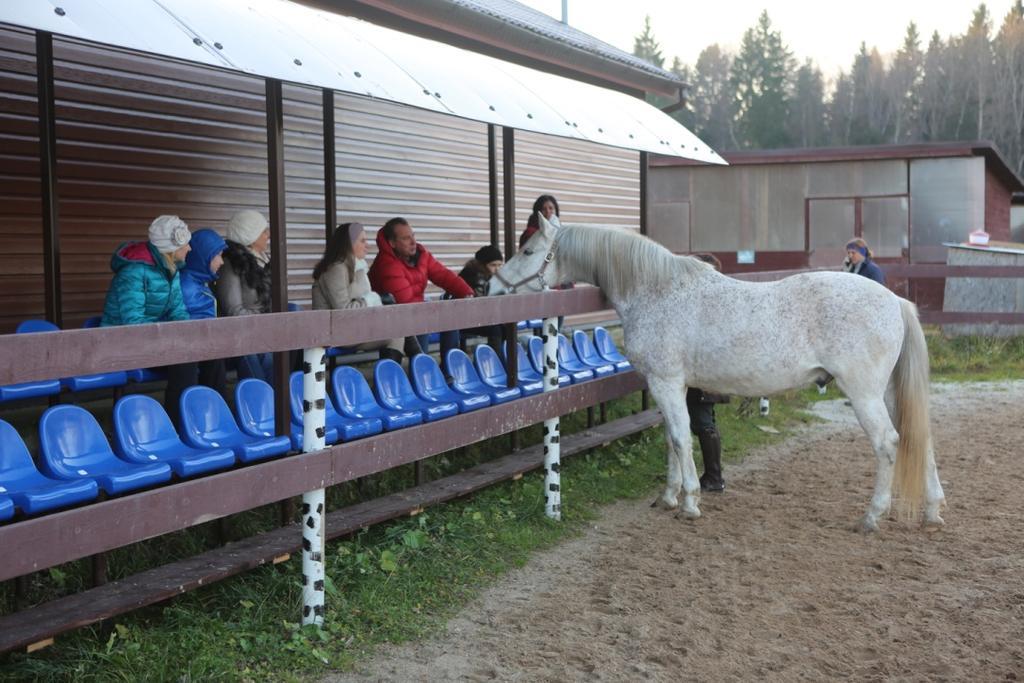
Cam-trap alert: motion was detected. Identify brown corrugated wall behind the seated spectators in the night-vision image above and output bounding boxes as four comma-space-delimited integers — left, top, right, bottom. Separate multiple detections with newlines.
0, 29, 639, 333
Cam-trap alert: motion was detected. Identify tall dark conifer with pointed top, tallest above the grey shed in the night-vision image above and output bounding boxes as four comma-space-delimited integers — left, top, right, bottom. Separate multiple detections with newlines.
730, 11, 794, 148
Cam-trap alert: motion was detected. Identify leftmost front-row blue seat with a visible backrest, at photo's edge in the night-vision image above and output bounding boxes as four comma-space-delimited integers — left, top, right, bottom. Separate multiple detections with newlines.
0, 420, 99, 515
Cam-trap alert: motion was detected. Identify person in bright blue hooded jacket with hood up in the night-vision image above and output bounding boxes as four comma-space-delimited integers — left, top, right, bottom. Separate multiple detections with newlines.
180, 227, 229, 400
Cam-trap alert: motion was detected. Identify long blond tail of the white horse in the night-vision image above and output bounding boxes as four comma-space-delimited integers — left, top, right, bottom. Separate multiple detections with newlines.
892, 299, 932, 517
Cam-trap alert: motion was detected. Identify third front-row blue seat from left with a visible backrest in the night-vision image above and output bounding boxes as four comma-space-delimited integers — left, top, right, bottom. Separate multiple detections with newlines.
114, 393, 234, 479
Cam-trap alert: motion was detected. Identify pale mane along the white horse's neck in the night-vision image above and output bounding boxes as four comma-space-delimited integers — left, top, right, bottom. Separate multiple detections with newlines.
558, 224, 713, 297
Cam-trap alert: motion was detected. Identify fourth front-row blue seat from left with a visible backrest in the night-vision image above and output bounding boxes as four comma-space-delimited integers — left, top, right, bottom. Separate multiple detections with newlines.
181, 386, 292, 463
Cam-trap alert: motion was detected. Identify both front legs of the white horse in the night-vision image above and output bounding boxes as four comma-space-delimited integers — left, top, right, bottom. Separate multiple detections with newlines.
647, 377, 700, 519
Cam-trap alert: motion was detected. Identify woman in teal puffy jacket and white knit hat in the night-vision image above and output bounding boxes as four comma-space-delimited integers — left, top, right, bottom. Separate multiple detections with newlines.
100, 216, 196, 429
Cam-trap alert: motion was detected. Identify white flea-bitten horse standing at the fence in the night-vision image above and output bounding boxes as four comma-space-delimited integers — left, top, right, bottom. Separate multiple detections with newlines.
488, 216, 945, 530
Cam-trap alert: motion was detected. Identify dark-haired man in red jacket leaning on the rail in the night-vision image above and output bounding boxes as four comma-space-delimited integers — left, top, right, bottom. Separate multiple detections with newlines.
369, 218, 473, 364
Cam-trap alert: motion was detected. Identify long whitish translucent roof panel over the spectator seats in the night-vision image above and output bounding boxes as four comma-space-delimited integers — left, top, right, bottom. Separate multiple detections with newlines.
0, 0, 725, 164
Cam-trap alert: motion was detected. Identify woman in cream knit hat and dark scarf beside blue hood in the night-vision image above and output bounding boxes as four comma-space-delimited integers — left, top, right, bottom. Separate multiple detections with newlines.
217, 209, 273, 382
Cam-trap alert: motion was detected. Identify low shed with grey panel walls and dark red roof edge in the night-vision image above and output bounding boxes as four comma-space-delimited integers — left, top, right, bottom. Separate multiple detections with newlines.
648, 142, 1024, 305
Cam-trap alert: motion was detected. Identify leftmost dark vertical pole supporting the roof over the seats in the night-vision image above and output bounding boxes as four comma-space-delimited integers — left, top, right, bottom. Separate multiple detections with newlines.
36, 31, 63, 328
